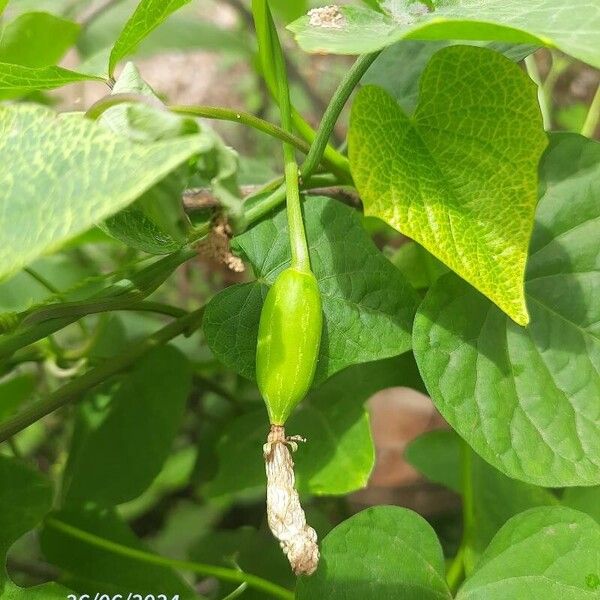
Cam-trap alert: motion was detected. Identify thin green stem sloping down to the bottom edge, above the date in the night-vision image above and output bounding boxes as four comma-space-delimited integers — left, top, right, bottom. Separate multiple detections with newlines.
45, 517, 294, 600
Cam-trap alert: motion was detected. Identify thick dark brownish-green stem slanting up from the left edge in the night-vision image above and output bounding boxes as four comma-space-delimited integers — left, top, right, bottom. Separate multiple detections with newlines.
0, 307, 204, 443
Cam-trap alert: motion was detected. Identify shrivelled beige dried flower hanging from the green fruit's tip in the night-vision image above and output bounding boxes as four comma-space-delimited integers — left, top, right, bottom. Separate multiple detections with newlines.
263, 425, 319, 575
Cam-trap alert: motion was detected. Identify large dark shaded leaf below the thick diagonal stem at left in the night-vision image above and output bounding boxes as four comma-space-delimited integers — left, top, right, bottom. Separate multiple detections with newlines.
63, 346, 191, 506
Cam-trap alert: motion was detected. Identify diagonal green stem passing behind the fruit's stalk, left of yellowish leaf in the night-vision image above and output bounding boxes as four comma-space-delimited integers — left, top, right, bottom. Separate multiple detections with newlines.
245, 52, 380, 223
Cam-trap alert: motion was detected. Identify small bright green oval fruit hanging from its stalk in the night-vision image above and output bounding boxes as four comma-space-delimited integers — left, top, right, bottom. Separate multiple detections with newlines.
256, 267, 323, 425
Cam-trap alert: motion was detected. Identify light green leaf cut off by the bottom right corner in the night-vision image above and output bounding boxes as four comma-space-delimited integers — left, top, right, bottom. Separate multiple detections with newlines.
456, 507, 600, 600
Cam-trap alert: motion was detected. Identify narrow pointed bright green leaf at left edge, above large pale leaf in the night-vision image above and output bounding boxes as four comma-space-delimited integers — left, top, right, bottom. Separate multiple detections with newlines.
0, 62, 104, 92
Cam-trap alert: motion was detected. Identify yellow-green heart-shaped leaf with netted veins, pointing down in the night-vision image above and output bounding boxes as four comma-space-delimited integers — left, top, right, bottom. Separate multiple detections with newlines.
348, 46, 546, 324
